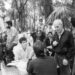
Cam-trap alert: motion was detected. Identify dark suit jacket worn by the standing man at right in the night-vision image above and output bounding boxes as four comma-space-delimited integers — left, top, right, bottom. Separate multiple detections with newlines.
54, 31, 75, 59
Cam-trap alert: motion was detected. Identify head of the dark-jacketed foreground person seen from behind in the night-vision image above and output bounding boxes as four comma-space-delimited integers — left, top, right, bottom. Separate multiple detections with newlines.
33, 40, 45, 57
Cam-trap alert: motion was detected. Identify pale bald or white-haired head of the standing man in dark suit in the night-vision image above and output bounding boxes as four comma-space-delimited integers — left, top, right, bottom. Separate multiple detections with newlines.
53, 19, 63, 33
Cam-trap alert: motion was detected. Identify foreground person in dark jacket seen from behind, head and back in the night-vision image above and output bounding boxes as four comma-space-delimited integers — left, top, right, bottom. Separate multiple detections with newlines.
27, 40, 57, 75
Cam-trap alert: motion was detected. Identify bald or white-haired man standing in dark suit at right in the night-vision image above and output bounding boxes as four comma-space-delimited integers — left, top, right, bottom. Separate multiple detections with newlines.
53, 19, 74, 75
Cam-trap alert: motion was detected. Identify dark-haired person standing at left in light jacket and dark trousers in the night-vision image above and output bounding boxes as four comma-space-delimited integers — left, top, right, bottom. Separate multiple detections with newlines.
6, 21, 18, 60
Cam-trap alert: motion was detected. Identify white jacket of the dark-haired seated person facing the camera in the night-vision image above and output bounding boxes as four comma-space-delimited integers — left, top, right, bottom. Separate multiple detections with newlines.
13, 43, 34, 60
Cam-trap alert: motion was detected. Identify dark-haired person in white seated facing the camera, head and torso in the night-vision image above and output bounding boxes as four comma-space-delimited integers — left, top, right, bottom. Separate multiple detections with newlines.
13, 37, 33, 60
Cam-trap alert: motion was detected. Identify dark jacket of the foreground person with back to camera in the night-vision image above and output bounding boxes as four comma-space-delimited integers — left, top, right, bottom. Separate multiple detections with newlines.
27, 57, 57, 75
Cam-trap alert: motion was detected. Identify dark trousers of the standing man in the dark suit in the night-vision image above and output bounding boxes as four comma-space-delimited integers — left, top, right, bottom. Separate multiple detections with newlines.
55, 54, 71, 75
